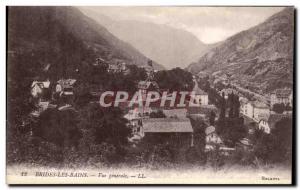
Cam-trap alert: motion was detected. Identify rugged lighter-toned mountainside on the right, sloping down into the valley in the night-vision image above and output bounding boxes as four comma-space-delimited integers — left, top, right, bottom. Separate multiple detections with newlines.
187, 7, 294, 93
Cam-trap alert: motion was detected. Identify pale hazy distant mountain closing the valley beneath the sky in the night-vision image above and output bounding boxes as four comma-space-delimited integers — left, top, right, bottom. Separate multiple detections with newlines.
78, 9, 212, 69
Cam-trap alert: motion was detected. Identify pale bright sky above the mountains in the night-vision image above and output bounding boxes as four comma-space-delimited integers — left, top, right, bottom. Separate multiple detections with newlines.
79, 6, 283, 44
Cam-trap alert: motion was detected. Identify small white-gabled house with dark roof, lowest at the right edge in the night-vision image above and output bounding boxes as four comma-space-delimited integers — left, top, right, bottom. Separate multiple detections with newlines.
258, 114, 292, 134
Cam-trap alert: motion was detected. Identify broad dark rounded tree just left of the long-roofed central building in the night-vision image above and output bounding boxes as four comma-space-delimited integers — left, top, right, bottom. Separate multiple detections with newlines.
78, 103, 131, 159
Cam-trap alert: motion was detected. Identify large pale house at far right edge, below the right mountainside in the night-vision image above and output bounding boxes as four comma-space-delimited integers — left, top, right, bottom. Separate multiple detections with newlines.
270, 89, 293, 107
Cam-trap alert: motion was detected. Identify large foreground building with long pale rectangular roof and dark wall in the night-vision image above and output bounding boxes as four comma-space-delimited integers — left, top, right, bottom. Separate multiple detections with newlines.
140, 118, 194, 148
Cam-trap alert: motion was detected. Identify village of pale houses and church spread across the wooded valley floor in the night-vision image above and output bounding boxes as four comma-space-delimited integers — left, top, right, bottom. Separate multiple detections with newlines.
23, 58, 293, 165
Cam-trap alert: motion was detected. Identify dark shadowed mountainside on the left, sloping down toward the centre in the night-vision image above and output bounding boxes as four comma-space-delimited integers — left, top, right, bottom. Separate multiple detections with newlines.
8, 7, 163, 81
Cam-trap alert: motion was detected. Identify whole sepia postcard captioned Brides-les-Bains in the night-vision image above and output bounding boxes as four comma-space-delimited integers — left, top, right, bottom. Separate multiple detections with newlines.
6, 6, 295, 185
